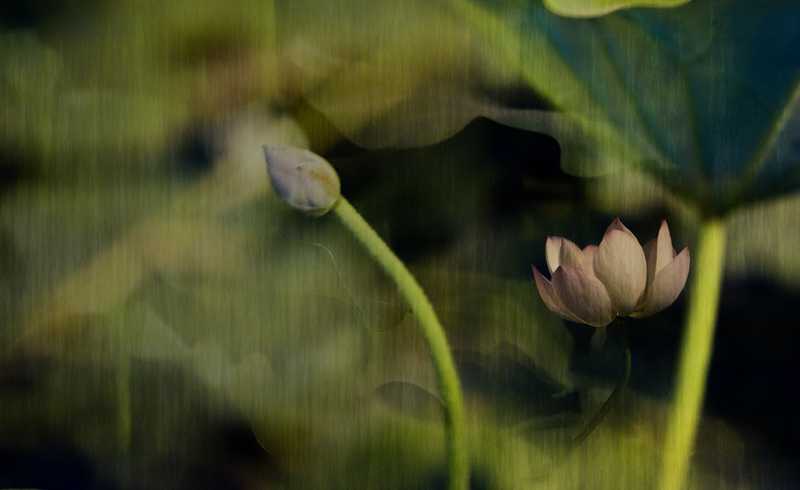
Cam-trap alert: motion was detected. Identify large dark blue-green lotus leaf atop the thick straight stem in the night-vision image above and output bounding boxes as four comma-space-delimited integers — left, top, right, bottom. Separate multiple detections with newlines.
455, 0, 800, 213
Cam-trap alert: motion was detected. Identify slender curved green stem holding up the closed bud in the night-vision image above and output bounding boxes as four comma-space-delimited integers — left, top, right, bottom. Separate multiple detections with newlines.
333, 197, 469, 490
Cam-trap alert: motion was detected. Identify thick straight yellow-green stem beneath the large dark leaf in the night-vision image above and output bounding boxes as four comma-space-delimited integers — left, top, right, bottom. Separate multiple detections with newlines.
659, 218, 725, 490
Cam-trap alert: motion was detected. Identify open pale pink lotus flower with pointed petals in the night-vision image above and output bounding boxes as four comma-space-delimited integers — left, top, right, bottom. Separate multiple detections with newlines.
533, 218, 689, 327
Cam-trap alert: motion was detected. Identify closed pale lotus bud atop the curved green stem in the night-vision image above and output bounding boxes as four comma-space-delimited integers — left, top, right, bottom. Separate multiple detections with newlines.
264, 146, 341, 216
